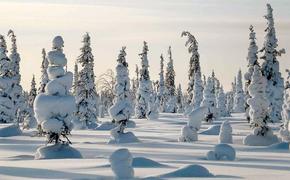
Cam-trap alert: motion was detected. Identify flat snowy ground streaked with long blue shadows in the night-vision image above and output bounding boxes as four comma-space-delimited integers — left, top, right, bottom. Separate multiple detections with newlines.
0, 113, 290, 180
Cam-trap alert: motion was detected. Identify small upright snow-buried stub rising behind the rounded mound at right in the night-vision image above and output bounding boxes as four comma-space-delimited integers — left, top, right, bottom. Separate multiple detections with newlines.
219, 120, 233, 144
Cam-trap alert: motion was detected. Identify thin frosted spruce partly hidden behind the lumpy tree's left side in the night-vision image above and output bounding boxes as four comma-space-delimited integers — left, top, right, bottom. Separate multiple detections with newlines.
38, 48, 49, 93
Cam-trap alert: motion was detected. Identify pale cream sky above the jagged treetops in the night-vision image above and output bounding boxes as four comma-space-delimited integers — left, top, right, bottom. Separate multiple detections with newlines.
0, 0, 290, 90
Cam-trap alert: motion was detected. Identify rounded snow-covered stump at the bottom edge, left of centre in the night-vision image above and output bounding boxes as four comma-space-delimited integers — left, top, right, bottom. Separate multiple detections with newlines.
109, 149, 134, 180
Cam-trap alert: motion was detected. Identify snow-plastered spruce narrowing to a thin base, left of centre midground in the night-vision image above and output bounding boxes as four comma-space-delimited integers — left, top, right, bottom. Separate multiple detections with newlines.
109, 47, 133, 133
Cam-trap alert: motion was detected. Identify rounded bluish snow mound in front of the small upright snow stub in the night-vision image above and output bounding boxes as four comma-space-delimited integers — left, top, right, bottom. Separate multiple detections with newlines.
206, 144, 236, 161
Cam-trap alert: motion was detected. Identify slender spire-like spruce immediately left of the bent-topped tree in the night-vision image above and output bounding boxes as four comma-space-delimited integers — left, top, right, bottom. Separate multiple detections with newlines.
165, 46, 177, 113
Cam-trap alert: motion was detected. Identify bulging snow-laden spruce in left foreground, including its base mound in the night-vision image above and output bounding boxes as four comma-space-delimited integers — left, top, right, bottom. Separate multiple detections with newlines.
34, 36, 81, 159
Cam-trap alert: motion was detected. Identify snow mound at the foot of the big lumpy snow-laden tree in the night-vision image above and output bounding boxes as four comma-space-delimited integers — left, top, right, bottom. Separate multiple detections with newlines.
34, 143, 82, 159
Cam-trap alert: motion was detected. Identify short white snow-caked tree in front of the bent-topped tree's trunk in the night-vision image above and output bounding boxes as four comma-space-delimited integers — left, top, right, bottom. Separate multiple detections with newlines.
191, 72, 203, 109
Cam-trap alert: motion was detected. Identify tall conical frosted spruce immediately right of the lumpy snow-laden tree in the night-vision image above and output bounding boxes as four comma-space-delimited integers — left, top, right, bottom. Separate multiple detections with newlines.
76, 33, 98, 129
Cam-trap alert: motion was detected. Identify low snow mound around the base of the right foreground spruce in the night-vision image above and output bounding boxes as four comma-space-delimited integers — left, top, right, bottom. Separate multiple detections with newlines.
243, 131, 279, 146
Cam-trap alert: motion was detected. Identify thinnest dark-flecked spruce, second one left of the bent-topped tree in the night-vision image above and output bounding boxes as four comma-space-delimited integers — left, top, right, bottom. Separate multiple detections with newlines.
157, 54, 166, 112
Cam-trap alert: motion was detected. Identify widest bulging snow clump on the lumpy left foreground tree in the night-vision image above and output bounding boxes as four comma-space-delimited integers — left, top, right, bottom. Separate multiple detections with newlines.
34, 94, 75, 133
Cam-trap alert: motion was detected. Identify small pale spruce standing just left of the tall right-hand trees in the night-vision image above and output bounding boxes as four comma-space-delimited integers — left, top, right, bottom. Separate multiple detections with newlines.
233, 70, 245, 113
